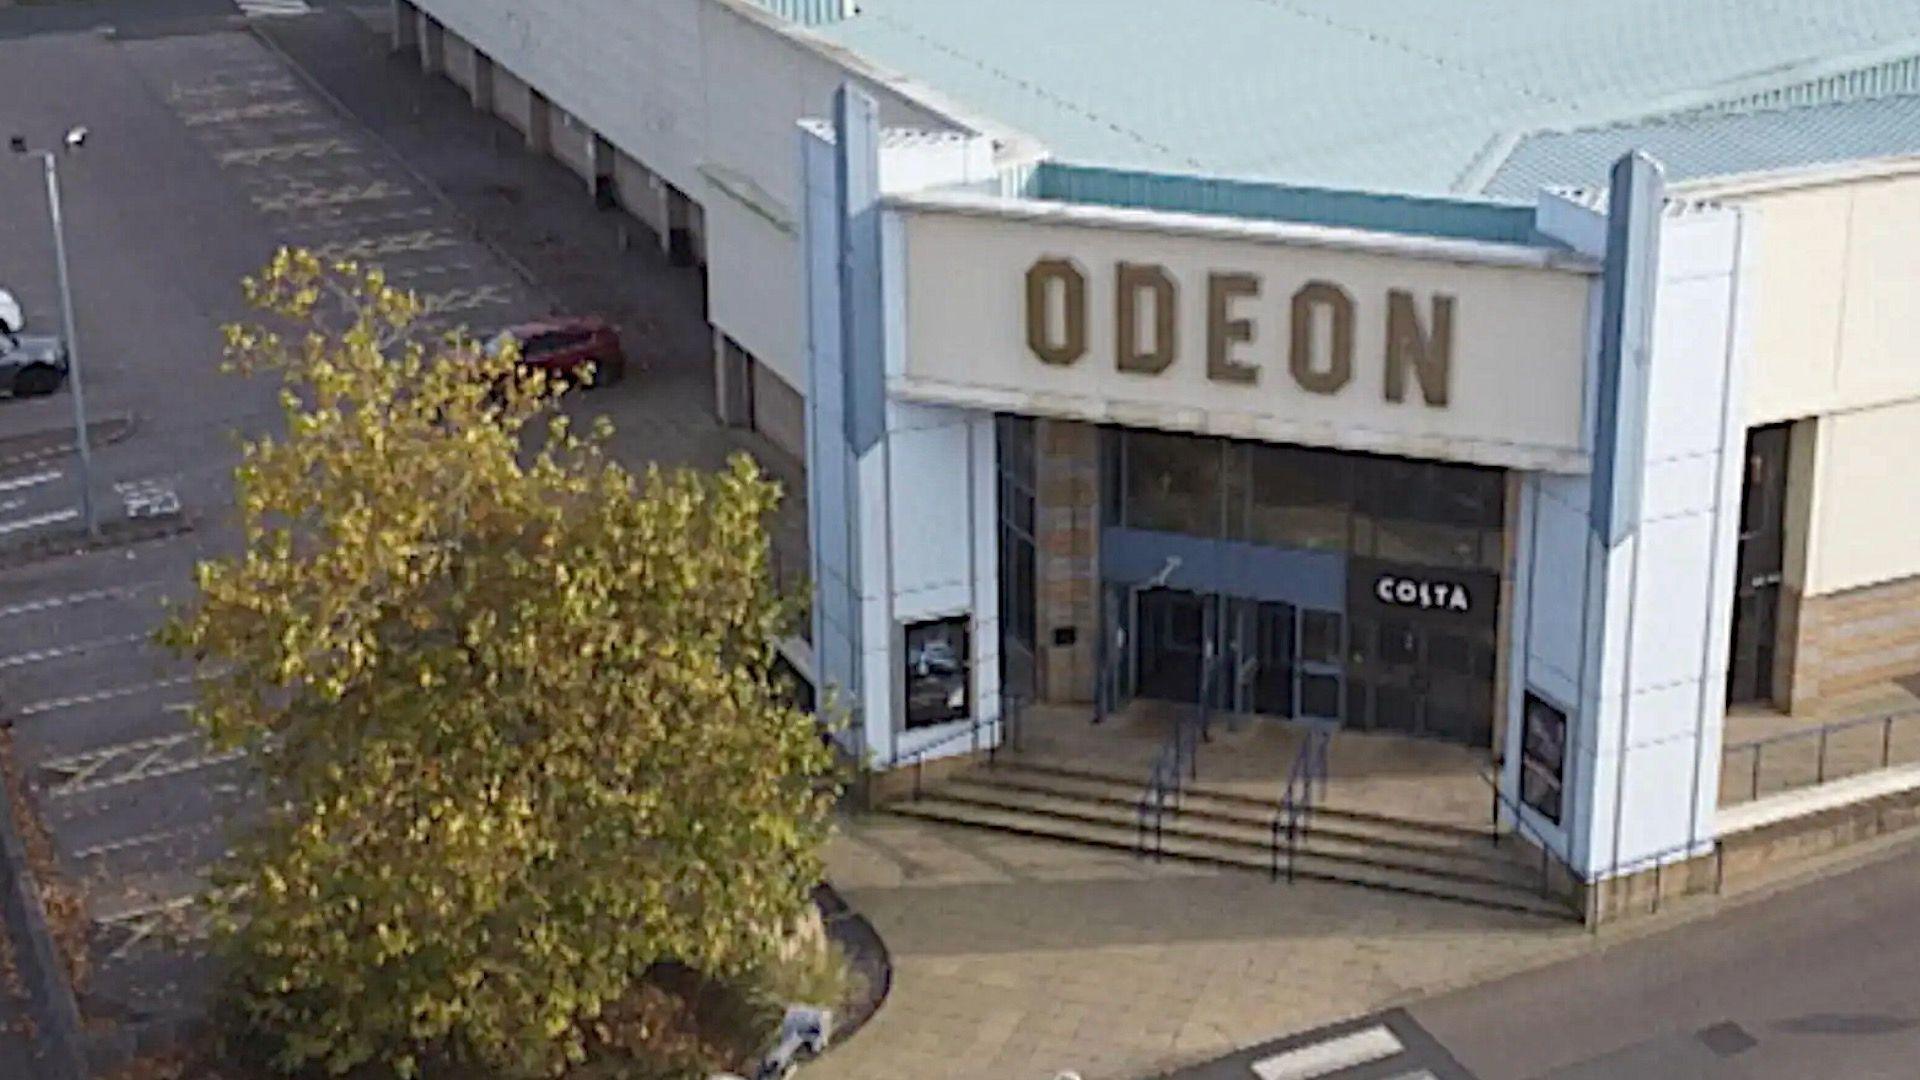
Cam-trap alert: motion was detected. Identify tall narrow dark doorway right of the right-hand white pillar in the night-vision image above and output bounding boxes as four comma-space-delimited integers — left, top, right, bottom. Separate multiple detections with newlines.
1726, 425, 1793, 705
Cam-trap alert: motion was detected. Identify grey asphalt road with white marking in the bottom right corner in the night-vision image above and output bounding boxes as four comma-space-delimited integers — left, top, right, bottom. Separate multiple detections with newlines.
1173, 844, 1920, 1080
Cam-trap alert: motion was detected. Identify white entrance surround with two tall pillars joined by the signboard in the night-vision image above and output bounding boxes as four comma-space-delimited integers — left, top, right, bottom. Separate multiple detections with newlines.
806, 92, 1751, 876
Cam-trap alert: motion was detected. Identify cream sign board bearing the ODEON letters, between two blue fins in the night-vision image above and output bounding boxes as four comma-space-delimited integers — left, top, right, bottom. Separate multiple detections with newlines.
889, 200, 1597, 471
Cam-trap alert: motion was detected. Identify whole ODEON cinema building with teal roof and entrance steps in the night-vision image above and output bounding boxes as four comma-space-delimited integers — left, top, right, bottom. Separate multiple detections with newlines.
396, 0, 1920, 919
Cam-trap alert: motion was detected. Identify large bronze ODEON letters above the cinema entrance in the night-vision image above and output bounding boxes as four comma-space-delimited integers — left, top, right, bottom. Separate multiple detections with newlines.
1025, 256, 1455, 409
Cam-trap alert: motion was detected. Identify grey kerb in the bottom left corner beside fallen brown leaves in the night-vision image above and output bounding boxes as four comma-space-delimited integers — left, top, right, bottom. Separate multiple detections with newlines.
0, 737, 88, 1080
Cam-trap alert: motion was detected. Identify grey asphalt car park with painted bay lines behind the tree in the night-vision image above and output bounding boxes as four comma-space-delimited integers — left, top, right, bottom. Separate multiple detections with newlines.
0, 6, 779, 1019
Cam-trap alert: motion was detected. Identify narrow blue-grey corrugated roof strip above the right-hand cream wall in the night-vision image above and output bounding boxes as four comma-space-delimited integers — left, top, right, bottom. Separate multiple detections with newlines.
1486, 94, 1920, 198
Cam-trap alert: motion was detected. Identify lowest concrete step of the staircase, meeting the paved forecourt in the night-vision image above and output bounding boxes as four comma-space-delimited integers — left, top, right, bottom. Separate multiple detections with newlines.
885, 794, 1576, 920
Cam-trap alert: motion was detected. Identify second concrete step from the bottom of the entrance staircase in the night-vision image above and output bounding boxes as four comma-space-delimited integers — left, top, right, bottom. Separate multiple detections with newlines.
935, 774, 1540, 892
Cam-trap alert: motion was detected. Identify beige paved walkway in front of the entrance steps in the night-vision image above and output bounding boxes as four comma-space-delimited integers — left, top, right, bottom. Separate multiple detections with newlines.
808, 817, 1592, 1080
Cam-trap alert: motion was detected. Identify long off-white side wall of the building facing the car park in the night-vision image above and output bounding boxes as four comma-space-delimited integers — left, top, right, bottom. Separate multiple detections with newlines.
407, 0, 1018, 418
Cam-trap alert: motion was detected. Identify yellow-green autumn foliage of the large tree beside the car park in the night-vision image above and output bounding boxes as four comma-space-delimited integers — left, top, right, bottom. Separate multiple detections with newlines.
161, 252, 831, 1074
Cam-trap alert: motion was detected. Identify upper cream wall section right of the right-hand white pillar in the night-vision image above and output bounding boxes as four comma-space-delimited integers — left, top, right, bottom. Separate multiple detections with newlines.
1709, 171, 1920, 425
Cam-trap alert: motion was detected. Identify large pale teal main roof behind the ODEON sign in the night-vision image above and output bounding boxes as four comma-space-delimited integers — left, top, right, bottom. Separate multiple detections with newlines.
814, 0, 1920, 194
